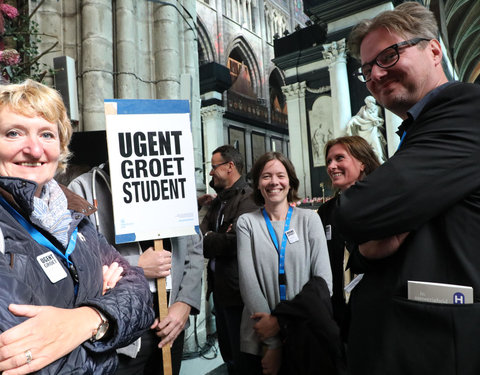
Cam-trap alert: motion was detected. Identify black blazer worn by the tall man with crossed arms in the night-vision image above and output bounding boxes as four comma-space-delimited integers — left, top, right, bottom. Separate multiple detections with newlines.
335, 83, 480, 375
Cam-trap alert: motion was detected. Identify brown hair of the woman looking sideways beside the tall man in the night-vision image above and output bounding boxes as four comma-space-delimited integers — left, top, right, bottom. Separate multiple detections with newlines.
325, 135, 380, 175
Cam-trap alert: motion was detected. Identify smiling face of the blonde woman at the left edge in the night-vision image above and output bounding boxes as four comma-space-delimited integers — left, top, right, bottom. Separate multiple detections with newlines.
0, 107, 60, 196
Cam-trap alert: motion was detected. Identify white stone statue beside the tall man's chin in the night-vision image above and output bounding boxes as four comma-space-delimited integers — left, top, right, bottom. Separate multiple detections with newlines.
347, 95, 387, 163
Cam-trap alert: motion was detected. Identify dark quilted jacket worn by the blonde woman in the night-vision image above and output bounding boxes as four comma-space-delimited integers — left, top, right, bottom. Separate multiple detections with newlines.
0, 177, 154, 374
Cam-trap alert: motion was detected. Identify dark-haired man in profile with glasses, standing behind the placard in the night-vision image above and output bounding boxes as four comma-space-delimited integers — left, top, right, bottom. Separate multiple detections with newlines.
199, 145, 257, 375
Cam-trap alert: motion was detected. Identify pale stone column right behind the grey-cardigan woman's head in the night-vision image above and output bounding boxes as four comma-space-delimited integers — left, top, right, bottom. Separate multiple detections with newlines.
282, 82, 312, 197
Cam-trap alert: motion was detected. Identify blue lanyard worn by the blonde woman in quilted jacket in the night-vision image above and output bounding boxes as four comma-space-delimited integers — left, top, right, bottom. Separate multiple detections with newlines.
0, 195, 78, 294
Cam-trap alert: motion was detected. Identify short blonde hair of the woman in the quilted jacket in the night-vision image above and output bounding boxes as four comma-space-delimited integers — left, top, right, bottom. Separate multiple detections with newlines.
0, 79, 73, 171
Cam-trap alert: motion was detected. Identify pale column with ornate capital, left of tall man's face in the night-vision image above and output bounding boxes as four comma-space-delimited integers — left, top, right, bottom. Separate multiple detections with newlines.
323, 39, 352, 137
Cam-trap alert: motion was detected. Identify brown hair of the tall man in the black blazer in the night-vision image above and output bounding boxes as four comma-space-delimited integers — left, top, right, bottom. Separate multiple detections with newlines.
348, 1, 438, 59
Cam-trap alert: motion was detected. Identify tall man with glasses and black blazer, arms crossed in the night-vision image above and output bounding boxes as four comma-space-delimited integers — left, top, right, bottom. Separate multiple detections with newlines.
335, 2, 480, 375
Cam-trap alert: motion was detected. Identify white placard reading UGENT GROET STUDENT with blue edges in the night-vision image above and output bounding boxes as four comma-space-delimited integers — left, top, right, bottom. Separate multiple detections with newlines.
105, 99, 198, 244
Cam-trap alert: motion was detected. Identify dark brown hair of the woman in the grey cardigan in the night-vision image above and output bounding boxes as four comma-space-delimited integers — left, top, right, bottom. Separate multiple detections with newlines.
251, 151, 300, 206
